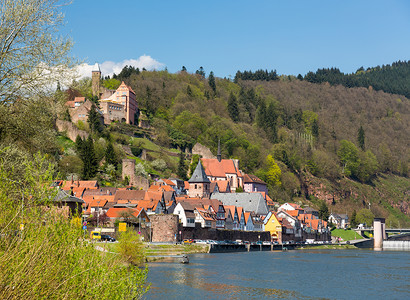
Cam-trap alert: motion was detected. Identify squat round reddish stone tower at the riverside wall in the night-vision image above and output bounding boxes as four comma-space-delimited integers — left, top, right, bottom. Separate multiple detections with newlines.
150, 215, 178, 243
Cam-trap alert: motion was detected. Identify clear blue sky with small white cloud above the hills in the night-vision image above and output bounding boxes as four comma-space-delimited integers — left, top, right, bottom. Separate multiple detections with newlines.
63, 0, 410, 78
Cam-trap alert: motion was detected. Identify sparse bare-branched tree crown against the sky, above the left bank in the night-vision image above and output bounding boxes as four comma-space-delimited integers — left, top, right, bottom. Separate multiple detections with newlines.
0, 0, 72, 104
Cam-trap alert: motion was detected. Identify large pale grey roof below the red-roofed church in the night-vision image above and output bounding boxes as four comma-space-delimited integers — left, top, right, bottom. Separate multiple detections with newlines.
211, 193, 268, 215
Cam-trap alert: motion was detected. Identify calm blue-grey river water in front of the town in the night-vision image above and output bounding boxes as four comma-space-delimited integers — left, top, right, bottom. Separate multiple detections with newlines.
144, 249, 410, 300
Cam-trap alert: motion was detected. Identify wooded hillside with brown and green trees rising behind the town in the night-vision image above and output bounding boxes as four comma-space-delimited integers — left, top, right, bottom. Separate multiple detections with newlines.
75, 67, 410, 222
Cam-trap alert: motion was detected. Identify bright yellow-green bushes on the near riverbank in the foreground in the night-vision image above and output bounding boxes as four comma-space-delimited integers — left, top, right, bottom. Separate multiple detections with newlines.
0, 156, 147, 299
